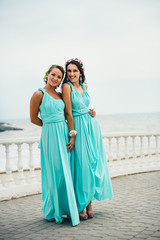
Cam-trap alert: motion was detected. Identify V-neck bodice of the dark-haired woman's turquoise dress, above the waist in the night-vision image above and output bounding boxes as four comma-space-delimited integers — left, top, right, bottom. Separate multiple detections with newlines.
68, 82, 90, 117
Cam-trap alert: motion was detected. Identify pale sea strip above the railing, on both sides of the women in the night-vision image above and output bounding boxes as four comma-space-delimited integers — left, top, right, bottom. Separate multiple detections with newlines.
0, 112, 160, 140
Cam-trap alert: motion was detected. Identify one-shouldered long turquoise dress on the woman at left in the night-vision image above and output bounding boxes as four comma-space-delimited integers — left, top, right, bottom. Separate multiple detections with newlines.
39, 88, 79, 226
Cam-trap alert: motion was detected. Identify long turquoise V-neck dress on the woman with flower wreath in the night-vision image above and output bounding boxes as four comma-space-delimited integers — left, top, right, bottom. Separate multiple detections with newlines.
68, 82, 113, 212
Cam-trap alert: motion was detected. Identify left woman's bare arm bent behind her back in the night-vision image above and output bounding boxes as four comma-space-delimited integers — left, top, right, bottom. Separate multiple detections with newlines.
30, 91, 43, 126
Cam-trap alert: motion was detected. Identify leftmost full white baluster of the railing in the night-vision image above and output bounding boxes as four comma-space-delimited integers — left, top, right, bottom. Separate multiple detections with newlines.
4, 144, 15, 187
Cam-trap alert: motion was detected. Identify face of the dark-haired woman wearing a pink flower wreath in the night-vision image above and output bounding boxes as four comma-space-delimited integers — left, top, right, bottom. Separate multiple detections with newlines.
67, 63, 81, 83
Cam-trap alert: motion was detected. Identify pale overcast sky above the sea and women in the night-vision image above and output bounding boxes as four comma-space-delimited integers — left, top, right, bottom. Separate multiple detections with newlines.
0, 0, 160, 119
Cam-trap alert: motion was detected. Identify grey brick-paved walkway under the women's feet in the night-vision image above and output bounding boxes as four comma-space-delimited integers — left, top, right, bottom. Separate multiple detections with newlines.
0, 171, 160, 240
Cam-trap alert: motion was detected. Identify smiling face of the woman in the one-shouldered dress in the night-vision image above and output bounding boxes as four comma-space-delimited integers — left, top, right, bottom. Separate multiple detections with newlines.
47, 68, 63, 87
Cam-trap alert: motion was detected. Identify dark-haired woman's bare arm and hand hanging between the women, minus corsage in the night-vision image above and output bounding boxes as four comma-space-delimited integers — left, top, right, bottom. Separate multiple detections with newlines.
62, 83, 75, 152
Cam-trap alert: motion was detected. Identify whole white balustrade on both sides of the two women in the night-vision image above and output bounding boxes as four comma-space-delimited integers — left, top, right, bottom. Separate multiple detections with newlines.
0, 133, 160, 200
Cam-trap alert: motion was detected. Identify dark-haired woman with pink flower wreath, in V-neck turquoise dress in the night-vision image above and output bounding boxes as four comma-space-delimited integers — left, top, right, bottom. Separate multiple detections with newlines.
62, 58, 113, 220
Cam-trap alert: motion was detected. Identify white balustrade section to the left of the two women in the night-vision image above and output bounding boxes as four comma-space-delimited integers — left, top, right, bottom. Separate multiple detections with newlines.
0, 138, 41, 201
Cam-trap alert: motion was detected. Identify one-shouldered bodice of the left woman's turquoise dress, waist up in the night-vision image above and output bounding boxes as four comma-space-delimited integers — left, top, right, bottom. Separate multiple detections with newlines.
38, 88, 65, 124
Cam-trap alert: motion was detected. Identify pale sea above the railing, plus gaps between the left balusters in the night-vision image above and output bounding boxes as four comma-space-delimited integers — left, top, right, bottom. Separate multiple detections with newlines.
0, 112, 160, 172
